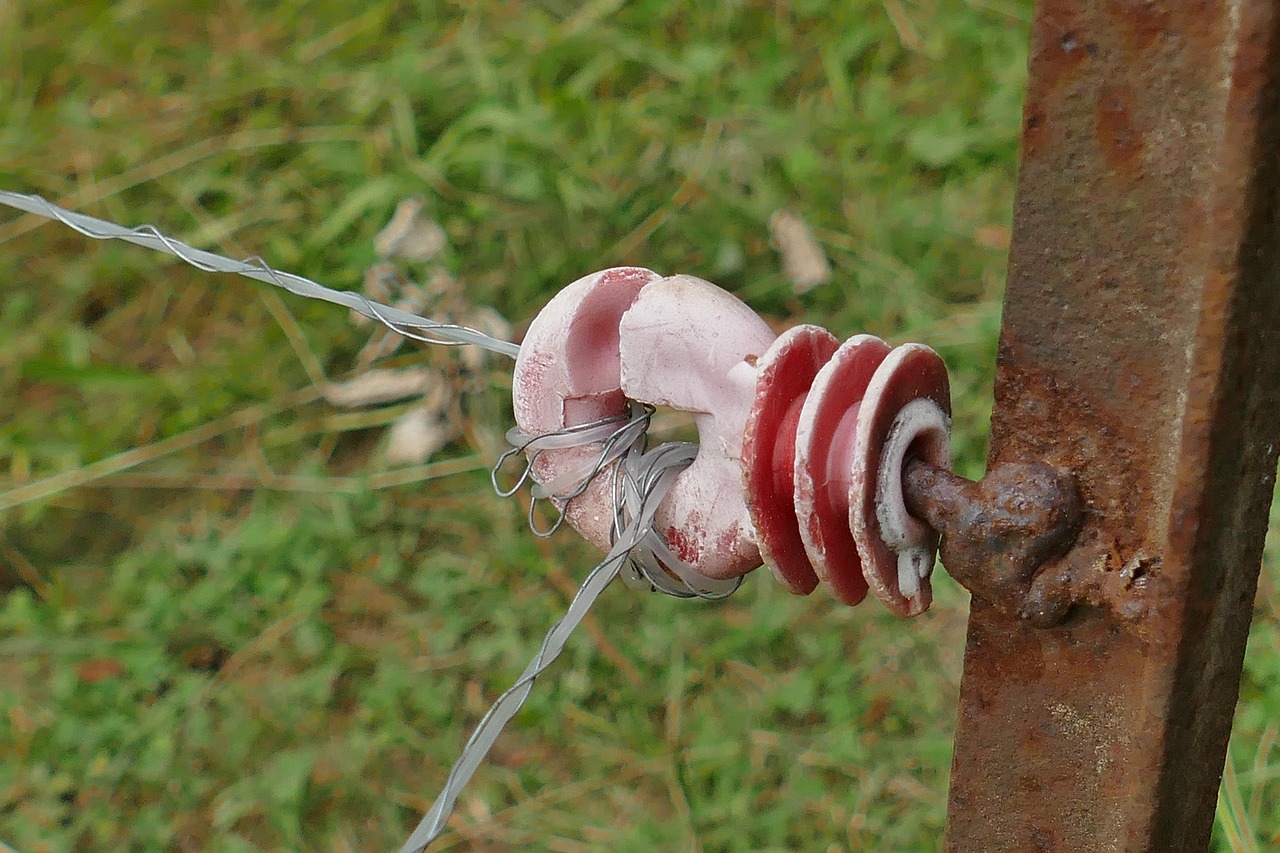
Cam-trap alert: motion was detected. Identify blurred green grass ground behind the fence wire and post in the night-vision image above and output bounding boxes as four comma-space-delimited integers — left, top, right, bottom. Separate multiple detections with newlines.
0, 0, 1280, 853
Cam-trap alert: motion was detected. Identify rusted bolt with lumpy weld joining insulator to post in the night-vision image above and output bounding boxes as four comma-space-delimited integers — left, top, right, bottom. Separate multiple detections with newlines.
902, 460, 1084, 626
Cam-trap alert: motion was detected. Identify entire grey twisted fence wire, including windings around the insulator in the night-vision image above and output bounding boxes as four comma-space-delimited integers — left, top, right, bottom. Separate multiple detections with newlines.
0, 190, 742, 853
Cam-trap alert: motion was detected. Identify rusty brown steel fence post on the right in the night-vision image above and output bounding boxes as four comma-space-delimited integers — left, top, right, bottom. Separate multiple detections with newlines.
943, 0, 1280, 852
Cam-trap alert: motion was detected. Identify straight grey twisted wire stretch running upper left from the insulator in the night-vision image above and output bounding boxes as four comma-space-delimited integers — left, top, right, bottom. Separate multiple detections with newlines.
0, 190, 520, 359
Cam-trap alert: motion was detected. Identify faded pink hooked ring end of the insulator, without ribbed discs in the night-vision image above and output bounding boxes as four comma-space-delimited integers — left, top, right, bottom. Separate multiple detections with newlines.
512, 268, 774, 579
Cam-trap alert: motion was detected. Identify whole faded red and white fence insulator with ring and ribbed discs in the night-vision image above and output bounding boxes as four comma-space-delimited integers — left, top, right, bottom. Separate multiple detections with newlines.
513, 268, 951, 616
